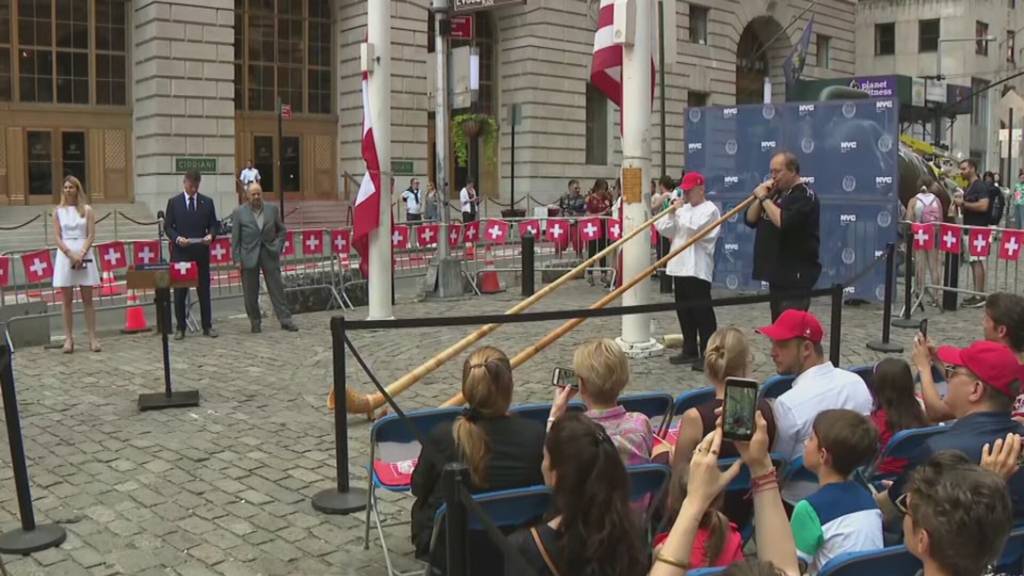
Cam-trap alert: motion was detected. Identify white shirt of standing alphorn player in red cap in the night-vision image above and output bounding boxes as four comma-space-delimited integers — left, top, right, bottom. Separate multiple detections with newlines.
654, 200, 721, 282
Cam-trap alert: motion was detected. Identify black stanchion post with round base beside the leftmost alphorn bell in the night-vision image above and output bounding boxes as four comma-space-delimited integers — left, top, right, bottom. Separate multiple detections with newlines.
312, 316, 367, 515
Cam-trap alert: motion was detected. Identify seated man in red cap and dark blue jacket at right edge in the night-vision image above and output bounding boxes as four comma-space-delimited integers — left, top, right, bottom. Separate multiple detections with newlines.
876, 335, 1024, 519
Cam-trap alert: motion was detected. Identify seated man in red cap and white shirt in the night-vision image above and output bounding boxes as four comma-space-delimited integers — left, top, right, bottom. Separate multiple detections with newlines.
758, 310, 873, 467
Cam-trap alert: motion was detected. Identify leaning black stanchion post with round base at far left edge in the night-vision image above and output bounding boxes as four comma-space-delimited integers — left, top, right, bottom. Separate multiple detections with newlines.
0, 327, 68, 554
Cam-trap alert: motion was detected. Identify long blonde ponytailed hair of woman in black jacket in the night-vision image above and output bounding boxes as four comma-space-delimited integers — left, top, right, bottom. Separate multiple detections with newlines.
452, 346, 512, 487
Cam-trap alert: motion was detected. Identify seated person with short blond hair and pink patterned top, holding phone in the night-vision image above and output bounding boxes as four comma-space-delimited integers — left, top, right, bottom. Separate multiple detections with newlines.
548, 338, 654, 465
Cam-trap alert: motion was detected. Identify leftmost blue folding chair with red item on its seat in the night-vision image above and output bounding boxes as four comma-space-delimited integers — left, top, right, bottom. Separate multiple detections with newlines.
362, 407, 462, 575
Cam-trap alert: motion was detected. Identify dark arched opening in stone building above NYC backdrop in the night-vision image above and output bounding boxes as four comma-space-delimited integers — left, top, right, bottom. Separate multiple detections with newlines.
736, 16, 793, 105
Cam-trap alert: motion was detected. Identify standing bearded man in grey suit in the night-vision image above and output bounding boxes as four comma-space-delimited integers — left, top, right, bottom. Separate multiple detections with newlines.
231, 182, 299, 333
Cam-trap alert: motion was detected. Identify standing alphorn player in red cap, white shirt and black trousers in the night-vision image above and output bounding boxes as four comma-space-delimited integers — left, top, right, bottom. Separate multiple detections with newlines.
655, 172, 721, 370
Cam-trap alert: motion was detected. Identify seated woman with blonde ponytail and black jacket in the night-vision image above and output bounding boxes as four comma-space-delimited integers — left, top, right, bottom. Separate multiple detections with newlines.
412, 346, 544, 564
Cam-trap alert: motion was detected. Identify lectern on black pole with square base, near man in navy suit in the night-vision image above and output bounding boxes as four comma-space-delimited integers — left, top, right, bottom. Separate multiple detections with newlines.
128, 262, 199, 411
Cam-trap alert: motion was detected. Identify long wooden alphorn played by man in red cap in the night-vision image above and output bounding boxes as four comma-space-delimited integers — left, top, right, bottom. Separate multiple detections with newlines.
327, 206, 672, 414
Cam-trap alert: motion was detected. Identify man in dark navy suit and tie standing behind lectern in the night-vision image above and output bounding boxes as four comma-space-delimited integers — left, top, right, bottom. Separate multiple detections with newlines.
164, 170, 219, 340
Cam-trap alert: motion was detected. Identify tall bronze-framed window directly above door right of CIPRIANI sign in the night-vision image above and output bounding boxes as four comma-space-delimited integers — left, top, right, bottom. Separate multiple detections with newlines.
234, 0, 334, 114
